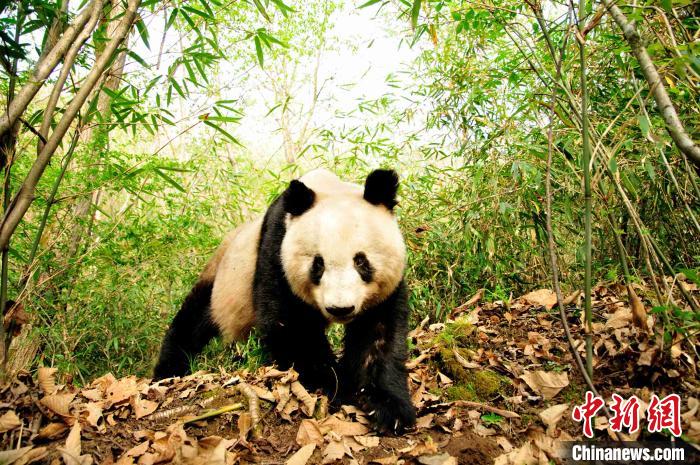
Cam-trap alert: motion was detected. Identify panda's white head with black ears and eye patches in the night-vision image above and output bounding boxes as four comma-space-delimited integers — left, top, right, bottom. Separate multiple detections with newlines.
281, 170, 406, 323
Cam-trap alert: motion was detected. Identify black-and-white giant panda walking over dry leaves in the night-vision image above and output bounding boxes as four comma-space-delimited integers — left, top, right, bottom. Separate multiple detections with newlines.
154, 169, 415, 433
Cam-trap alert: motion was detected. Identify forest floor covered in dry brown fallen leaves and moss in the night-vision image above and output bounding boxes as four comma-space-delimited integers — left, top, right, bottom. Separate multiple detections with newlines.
0, 283, 700, 465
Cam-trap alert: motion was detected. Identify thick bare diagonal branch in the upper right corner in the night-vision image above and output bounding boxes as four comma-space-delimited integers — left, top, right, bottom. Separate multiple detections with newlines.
603, 0, 700, 168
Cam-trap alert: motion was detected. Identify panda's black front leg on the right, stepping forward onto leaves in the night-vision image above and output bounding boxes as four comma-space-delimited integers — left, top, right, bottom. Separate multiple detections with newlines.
341, 283, 416, 434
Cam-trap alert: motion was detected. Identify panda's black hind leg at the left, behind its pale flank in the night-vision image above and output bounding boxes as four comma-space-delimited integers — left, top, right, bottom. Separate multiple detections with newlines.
153, 281, 219, 380
